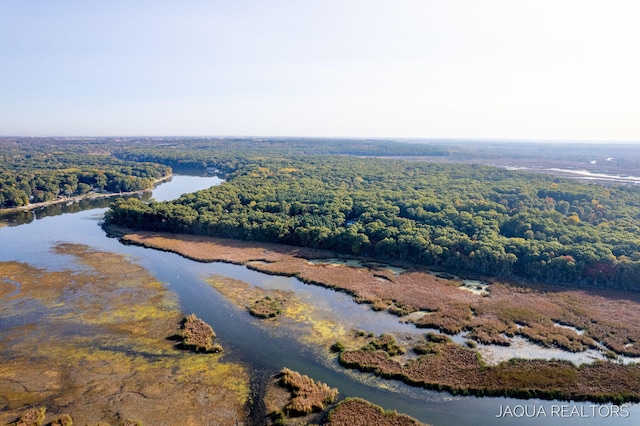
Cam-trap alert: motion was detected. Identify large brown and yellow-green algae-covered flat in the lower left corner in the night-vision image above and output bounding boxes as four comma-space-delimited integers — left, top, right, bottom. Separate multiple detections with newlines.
0, 244, 249, 425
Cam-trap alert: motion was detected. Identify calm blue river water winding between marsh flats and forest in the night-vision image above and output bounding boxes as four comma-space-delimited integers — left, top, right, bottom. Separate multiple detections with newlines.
0, 176, 640, 425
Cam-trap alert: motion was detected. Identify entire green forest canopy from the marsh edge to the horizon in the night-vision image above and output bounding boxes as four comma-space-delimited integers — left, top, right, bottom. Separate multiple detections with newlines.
0, 138, 640, 290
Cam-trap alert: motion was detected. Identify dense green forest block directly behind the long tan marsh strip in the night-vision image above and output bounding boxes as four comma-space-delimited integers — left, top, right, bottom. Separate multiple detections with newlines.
107, 146, 640, 290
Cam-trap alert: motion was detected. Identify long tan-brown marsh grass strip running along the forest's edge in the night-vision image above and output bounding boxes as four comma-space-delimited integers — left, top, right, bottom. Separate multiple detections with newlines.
125, 232, 640, 356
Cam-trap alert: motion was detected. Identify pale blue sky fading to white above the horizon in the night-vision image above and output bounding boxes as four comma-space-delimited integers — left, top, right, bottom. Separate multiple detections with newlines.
0, 0, 640, 143
